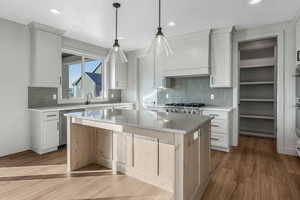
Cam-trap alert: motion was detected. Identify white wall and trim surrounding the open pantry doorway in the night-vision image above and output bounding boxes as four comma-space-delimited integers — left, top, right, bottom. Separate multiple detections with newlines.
233, 20, 296, 155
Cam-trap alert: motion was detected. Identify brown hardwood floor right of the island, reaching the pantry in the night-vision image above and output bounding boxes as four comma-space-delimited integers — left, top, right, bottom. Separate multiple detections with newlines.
203, 136, 300, 200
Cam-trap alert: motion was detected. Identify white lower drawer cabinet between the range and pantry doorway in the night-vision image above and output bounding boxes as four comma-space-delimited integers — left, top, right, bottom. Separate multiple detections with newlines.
203, 110, 232, 152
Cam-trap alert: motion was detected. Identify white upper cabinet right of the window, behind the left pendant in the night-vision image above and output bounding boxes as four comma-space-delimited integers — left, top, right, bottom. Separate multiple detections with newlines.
109, 57, 127, 90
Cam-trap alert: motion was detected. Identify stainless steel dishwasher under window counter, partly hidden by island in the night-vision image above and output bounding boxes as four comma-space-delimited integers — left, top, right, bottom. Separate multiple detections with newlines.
59, 109, 85, 146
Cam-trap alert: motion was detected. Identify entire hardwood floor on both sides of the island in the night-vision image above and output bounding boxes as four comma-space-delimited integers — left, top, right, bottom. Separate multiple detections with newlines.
0, 136, 300, 200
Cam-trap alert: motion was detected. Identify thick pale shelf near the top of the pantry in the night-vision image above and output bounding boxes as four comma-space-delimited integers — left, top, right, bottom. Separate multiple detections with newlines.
240, 57, 275, 69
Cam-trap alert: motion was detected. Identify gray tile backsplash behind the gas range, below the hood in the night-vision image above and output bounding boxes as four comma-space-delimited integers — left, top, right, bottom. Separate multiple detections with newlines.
157, 77, 233, 106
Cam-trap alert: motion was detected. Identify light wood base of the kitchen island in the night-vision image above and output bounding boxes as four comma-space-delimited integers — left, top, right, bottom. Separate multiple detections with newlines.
67, 117, 210, 200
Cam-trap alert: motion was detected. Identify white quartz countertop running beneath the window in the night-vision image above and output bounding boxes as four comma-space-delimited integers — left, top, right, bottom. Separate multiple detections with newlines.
29, 103, 133, 112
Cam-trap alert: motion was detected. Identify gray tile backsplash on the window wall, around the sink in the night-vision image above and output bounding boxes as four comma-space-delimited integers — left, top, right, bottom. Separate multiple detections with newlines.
28, 87, 121, 108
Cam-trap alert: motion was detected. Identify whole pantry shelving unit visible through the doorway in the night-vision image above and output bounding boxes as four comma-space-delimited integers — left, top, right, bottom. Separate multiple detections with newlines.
239, 39, 277, 138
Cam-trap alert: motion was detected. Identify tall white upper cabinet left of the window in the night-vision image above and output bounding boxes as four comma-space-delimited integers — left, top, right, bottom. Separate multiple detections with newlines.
29, 23, 63, 87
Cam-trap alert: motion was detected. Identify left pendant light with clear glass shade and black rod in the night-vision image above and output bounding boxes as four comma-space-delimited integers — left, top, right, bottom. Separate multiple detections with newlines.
105, 3, 127, 63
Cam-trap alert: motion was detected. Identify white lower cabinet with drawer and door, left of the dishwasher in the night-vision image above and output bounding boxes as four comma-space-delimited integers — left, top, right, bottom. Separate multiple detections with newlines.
30, 111, 59, 154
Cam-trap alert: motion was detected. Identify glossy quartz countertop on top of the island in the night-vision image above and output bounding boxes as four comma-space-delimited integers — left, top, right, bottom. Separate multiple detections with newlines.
65, 109, 213, 134
